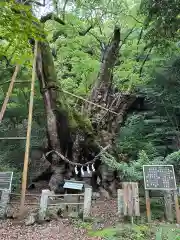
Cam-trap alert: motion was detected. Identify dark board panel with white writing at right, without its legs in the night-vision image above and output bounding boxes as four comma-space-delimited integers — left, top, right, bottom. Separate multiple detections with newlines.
143, 165, 177, 190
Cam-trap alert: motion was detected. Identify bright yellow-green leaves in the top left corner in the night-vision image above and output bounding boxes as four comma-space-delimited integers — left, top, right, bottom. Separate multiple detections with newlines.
0, 0, 45, 65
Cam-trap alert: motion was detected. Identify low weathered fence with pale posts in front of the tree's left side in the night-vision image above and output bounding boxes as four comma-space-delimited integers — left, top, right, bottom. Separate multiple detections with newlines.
0, 187, 92, 220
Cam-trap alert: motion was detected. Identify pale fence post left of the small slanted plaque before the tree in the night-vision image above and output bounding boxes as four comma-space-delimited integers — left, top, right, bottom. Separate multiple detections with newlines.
39, 189, 50, 221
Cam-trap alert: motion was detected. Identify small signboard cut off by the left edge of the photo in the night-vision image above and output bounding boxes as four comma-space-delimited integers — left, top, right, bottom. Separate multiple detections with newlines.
0, 172, 13, 190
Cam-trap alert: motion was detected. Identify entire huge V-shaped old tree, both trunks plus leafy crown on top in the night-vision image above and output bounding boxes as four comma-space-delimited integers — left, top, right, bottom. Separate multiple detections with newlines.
1, 0, 146, 195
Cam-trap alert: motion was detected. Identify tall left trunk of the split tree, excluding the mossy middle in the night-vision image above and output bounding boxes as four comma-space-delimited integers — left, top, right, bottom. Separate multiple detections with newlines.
37, 42, 72, 191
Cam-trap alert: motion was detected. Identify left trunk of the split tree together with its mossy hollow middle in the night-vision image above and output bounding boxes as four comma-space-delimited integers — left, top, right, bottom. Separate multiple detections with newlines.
36, 42, 100, 192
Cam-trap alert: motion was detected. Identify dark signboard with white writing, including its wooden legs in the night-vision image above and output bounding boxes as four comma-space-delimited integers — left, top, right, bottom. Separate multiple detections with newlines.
143, 165, 180, 224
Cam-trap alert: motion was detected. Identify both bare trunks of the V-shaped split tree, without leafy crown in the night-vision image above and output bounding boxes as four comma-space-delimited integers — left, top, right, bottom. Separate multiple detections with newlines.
15, 0, 134, 195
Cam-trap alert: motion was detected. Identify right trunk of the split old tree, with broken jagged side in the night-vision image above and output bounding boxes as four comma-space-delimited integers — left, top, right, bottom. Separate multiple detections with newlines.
84, 27, 135, 195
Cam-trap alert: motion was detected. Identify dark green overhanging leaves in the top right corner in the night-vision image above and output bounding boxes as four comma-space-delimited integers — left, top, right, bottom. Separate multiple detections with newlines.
141, 0, 180, 42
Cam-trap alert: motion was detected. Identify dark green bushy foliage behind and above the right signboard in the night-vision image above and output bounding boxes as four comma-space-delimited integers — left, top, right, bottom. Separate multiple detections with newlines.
112, 53, 180, 180
